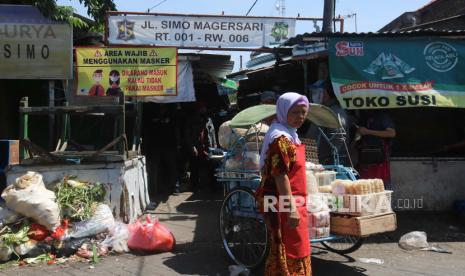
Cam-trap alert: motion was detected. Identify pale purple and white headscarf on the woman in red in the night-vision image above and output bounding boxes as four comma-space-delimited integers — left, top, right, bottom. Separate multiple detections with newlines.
260, 92, 308, 169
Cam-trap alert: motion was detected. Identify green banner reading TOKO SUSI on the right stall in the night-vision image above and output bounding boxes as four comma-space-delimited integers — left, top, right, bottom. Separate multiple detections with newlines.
328, 37, 465, 109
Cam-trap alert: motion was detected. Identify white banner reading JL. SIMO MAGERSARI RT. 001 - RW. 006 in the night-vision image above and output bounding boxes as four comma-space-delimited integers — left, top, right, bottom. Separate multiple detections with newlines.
107, 13, 296, 48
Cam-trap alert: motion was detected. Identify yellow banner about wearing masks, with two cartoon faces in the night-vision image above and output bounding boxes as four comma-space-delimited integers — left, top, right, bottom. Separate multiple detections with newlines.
76, 47, 178, 96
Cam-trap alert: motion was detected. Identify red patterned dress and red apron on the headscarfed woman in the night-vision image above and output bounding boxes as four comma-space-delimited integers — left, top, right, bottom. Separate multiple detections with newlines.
257, 136, 312, 276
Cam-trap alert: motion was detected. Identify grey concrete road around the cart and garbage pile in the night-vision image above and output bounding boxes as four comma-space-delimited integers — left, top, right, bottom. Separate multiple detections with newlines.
0, 193, 465, 276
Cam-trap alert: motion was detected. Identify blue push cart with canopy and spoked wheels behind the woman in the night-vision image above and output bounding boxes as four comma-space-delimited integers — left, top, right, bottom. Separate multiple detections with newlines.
216, 104, 363, 269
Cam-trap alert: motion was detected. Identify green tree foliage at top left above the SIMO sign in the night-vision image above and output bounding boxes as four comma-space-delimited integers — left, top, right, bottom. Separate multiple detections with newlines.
1, 0, 116, 29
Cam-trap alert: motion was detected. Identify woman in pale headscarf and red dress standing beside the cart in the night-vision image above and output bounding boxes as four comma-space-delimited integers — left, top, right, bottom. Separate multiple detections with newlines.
256, 92, 312, 275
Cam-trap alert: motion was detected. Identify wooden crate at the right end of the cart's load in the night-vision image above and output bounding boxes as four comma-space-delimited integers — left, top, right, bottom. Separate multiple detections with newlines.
330, 212, 397, 237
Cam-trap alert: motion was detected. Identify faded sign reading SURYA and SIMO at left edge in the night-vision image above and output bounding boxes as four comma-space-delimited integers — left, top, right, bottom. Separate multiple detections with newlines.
0, 23, 72, 79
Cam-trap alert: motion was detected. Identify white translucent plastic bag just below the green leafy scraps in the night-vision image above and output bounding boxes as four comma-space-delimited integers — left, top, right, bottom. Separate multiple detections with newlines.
64, 204, 115, 240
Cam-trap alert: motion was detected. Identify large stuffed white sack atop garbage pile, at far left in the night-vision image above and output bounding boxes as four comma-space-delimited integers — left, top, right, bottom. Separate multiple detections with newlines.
2, 172, 60, 231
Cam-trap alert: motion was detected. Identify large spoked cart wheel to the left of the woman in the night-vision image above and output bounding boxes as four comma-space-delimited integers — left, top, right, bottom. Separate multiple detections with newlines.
219, 187, 268, 269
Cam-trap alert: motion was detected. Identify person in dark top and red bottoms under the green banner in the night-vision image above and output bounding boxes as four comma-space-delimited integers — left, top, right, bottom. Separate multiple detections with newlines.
355, 110, 396, 190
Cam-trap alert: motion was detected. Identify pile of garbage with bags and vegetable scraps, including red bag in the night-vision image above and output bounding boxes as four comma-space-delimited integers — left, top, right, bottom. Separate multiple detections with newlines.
0, 172, 175, 268
